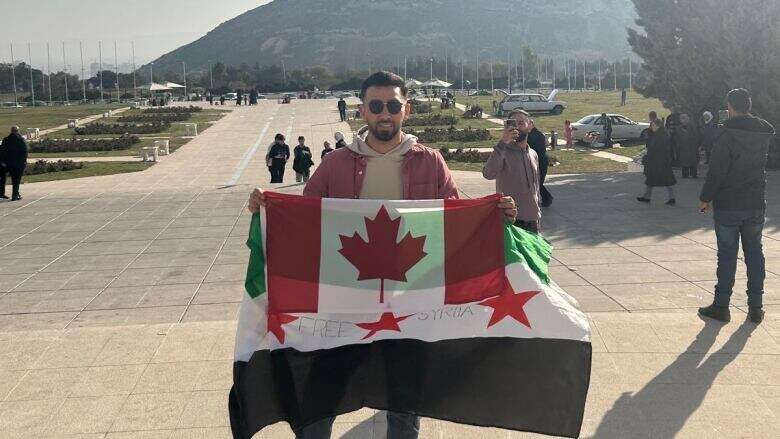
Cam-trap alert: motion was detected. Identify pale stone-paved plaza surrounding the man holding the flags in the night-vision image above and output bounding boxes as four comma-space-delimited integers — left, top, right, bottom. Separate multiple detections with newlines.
0, 100, 780, 439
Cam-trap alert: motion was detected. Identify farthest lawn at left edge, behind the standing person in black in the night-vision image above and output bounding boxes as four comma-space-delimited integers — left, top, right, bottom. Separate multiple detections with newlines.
0, 104, 127, 134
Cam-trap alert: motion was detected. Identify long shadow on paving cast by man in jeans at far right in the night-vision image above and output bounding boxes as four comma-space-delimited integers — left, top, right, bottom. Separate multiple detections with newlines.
593, 319, 756, 439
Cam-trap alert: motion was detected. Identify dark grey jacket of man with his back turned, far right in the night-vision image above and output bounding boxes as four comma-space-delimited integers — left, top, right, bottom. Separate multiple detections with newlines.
699, 116, 775, 210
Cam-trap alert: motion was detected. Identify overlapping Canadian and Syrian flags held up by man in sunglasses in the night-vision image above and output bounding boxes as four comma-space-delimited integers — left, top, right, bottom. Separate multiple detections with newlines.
229, 193, 591, 438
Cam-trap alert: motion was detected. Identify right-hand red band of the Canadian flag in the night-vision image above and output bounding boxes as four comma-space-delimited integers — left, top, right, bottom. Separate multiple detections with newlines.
444, 195, 506, 304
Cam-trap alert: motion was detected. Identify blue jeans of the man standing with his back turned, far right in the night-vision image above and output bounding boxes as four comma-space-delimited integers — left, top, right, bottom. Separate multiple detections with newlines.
714, 209, 766, 308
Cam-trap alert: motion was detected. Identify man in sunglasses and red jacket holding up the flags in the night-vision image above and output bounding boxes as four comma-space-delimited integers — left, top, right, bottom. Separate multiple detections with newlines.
249, 72, 516, 439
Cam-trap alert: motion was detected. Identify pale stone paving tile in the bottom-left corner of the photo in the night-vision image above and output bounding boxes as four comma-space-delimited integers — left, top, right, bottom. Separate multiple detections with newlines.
0, 399, 64, 438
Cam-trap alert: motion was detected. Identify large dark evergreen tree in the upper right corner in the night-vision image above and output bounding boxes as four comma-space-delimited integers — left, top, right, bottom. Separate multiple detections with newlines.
628, 0, 780, 124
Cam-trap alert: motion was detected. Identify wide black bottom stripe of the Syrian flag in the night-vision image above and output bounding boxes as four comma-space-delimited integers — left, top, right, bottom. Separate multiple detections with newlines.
230, 338, 591, 439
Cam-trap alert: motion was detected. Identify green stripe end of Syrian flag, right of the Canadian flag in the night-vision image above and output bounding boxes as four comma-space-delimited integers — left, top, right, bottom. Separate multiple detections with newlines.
504, 224, 552, 284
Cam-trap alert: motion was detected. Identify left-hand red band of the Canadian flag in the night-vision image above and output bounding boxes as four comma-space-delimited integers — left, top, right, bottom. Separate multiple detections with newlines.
265, 192, 322, 314
